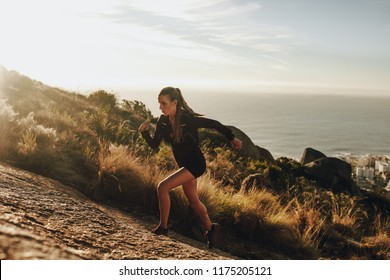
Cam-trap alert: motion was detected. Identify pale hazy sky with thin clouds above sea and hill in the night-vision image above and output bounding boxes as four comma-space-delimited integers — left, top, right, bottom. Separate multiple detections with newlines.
0, 0, 390, 97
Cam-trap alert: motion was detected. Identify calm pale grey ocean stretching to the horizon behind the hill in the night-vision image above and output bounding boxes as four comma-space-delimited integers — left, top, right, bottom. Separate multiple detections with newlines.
121, 92, 390, 160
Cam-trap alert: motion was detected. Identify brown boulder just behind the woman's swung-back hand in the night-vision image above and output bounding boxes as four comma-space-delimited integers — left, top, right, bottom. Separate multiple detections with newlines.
227, 126, 275, 163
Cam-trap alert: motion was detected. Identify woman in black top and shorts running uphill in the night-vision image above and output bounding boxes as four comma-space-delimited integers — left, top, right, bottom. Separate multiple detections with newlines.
139, 87, 242, 248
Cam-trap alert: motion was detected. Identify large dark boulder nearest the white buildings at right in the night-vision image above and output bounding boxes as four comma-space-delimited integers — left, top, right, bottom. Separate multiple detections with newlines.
303, 157, 361, 195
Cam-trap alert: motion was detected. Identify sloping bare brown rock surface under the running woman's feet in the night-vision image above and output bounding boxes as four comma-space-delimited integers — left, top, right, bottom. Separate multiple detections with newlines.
0, 163, 234, 260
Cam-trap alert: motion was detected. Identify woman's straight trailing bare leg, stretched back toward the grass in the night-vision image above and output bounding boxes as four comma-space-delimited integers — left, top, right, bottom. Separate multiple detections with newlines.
183, 178, 211, 231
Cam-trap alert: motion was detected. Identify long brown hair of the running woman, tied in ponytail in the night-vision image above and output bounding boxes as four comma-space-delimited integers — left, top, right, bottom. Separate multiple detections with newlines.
158, 87, 202, 143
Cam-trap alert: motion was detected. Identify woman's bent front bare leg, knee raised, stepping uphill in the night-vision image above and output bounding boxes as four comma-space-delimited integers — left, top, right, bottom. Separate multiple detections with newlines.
157, 167, 195, 228
